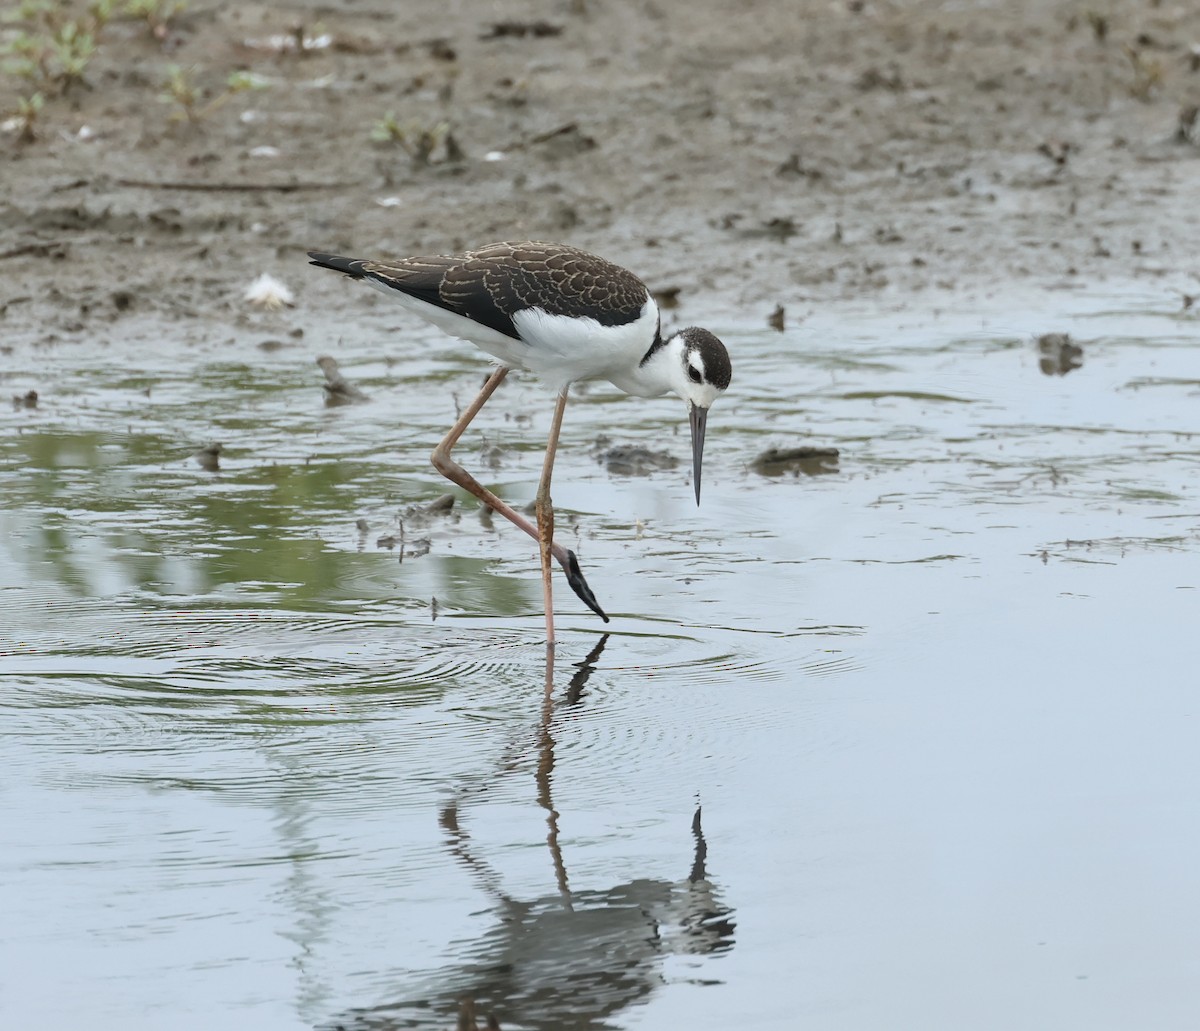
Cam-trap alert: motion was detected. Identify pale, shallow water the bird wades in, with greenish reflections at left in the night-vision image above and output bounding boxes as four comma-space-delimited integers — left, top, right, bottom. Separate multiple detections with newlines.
0, 284, 1200, 1031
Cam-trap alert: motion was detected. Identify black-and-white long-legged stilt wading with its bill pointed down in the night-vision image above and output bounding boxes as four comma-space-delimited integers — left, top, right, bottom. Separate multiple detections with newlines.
308, 241, 731, 645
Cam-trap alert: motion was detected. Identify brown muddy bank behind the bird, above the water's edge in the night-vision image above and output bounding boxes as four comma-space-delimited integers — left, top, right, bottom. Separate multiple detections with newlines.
0, 0, 1200, 347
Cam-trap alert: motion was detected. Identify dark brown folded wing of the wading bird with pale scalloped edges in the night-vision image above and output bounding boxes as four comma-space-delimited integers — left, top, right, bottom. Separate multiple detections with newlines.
355, 241, 649, 338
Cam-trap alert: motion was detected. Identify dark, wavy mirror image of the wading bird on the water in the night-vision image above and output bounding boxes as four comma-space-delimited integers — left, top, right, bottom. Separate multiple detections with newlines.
330, 635, 734, 1031
